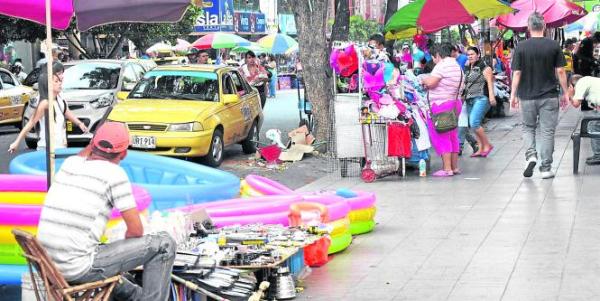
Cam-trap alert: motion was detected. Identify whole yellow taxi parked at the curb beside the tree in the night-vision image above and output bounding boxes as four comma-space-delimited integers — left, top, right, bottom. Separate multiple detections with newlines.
108, 65, 263, 166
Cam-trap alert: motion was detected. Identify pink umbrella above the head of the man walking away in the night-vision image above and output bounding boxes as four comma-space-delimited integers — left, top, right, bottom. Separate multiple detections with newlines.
496, 0, 587, 31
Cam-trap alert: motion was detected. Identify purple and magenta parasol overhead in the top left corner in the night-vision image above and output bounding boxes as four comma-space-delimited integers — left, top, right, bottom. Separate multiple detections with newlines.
0, 0, 191, 31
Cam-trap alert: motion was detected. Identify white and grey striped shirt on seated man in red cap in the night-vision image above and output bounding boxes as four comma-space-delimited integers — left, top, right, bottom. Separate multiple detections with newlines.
38, 156, 136, 281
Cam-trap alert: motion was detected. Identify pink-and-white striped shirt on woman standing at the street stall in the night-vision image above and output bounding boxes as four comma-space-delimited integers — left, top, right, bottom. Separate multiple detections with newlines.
429, 57, 462, 105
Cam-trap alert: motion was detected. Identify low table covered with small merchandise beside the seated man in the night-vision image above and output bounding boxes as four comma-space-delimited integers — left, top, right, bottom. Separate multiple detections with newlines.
164, 224, 326, 300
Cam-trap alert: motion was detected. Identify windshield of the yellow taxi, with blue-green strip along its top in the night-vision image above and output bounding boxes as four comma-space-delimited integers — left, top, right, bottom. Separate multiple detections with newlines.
128, 71, 219, 102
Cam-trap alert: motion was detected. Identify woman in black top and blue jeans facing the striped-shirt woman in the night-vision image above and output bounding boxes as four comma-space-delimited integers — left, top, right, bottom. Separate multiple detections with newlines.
463, 47, 496, 157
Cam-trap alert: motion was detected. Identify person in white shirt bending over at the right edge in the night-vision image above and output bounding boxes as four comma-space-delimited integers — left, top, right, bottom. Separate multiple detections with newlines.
569, 74, 600, 165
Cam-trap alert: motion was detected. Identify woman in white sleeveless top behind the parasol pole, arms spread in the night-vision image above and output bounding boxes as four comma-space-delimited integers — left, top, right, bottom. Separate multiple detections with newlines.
8, 62, 88, 153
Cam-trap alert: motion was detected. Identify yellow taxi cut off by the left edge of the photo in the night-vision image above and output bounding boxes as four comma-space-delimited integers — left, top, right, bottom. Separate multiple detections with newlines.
0, 68, 36, 127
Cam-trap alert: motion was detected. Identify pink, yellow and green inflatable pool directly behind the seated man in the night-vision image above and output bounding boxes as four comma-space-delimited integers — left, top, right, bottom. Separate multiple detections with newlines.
0, 174, 151, 284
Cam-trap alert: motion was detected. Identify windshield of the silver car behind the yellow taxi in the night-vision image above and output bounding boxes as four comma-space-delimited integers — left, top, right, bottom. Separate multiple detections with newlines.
63, 62, 121, 90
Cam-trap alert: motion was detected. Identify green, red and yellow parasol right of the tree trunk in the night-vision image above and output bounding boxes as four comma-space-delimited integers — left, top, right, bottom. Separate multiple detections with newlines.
385, 0, 513, 37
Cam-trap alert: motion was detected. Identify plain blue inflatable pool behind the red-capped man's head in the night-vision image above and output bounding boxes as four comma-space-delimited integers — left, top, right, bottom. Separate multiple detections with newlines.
9, 148, 240, 211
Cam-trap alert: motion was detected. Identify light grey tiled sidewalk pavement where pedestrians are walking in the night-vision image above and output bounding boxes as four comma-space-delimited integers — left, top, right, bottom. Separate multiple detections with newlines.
298, 109, 600, 301
